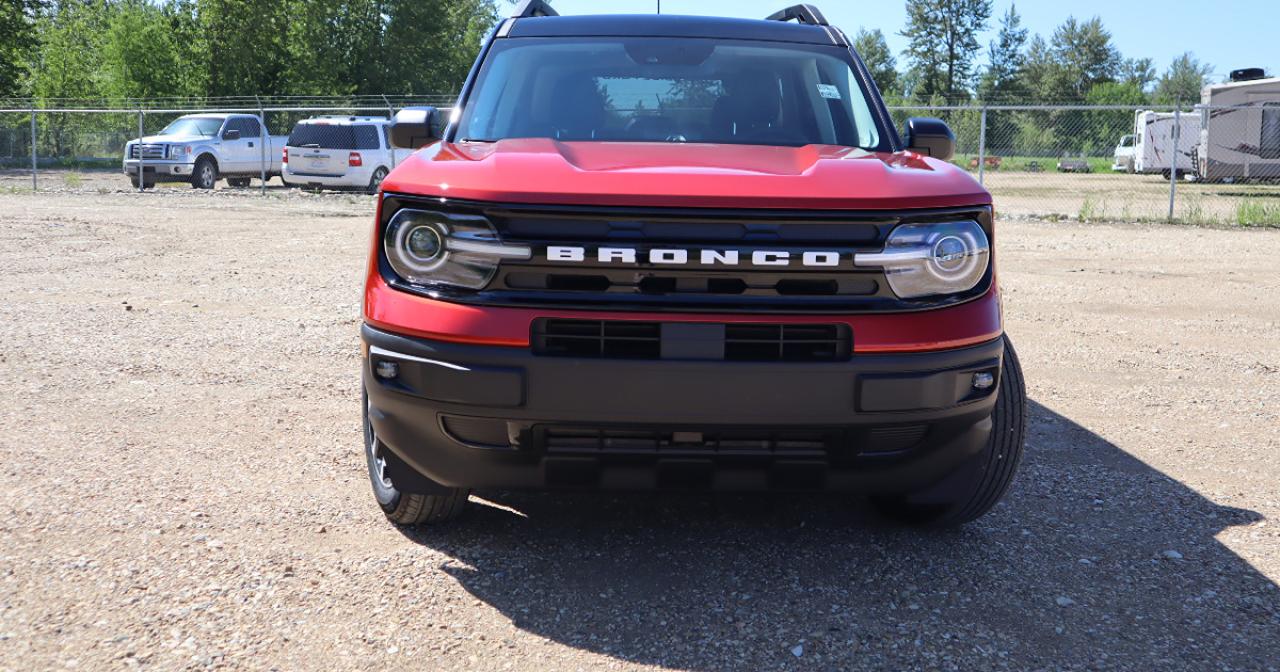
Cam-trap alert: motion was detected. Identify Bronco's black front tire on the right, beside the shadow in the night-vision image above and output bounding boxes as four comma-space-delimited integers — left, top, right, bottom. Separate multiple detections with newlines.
872, 337, 1027, 527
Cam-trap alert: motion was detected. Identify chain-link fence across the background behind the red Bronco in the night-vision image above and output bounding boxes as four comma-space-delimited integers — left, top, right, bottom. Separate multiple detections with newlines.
0, 96, 1280, 225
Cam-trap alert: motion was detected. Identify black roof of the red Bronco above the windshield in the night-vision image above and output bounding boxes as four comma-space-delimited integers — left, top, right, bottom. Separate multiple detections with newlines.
499, 14, 847, 46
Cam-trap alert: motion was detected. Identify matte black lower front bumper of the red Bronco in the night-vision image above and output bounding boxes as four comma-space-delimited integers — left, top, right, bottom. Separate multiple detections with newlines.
362, 325, 1004, 493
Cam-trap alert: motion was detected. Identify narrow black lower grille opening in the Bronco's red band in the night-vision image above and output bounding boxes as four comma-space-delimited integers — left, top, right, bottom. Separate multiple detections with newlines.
532, 319, 854, 362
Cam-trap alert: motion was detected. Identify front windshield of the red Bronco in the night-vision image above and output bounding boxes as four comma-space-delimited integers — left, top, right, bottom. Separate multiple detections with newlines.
453, 37, 881, 148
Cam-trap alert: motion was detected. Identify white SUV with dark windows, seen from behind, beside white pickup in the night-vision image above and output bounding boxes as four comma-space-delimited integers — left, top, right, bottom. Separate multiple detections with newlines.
282, 116, 412, 193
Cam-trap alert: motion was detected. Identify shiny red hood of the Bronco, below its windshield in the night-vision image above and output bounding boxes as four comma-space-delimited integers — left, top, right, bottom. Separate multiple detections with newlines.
383, 138, 991, 210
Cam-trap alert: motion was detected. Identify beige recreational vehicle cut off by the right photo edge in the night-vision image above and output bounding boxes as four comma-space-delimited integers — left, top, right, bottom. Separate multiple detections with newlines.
1196, 68, 1280, 182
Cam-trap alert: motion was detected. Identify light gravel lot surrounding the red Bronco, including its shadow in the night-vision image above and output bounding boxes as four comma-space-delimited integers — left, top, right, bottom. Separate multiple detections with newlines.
0, 187, 1280, 671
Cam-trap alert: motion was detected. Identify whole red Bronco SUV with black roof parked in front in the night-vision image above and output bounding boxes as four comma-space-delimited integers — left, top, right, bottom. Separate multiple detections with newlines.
362, 0, 1025, 525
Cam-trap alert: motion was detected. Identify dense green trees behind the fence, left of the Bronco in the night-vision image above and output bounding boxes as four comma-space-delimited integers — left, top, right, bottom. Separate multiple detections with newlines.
15, 0, 498, 104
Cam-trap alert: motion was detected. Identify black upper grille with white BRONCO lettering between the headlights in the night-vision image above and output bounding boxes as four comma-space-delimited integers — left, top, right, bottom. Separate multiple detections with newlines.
373, 195, 991, 314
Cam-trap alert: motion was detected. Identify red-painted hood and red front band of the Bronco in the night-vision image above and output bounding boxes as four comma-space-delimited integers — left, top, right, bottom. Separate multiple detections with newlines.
365, 138, 1004, 353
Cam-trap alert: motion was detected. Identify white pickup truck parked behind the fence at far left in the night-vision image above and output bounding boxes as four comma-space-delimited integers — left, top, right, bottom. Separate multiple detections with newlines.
124, 114, 288, 189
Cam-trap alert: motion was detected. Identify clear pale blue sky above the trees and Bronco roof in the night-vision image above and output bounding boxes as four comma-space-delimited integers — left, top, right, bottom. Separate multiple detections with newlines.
537, 0, 1280, 79
